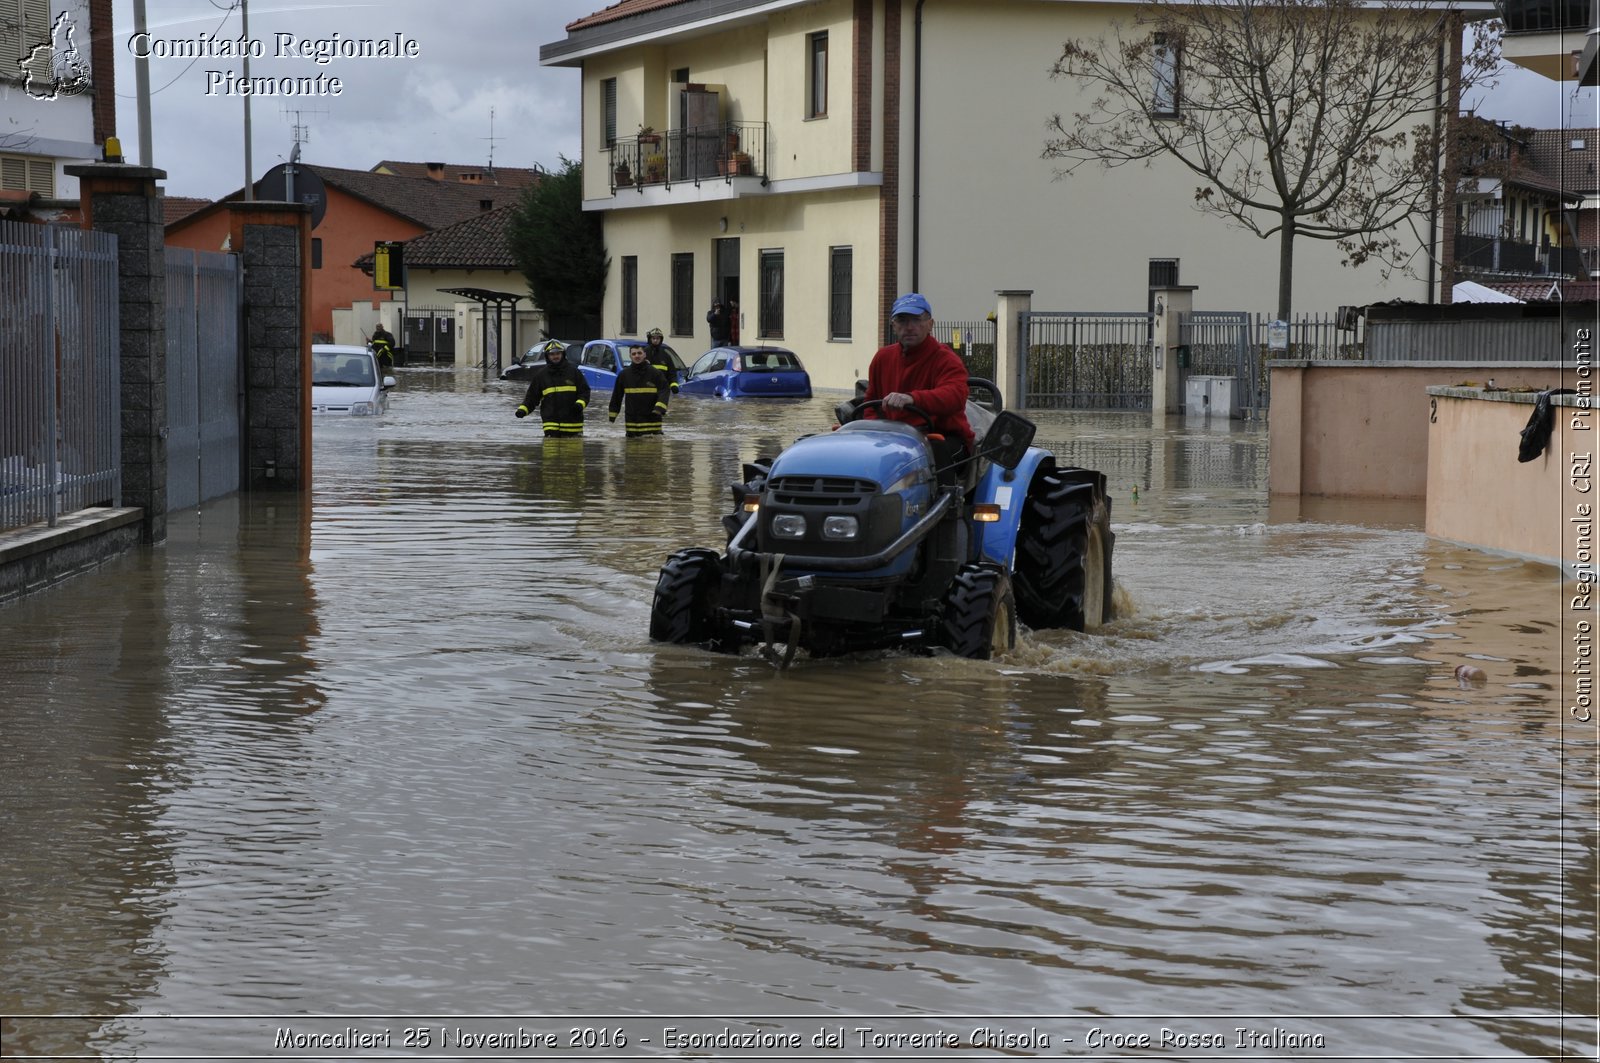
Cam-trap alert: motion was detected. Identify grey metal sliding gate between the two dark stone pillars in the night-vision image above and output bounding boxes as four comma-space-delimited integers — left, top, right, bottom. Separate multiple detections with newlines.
166, 247, 245, 512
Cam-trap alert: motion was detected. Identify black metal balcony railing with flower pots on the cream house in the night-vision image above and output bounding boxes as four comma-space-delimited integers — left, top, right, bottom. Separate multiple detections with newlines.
610, 122, 766, 195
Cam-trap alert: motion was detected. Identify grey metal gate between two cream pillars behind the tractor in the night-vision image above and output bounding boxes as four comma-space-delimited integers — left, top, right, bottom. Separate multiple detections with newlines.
1021, 311, 1155, 410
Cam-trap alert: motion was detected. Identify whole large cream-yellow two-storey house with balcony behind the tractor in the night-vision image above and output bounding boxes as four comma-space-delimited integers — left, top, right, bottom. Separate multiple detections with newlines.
541, 0, 1493, 387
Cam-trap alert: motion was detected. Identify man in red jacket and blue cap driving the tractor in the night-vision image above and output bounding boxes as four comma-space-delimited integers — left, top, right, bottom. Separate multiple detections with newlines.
866, 291, 976, 458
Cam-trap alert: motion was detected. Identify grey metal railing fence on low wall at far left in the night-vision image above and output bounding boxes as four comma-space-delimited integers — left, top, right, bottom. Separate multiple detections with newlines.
0, 223, 122, 530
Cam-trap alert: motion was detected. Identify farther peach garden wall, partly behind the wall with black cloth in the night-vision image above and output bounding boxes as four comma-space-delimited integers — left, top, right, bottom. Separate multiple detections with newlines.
1267, 360, 1573, 498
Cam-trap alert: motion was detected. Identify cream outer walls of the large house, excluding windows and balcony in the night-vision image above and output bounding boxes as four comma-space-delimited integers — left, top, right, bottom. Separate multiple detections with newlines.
565, 0, 1488, 389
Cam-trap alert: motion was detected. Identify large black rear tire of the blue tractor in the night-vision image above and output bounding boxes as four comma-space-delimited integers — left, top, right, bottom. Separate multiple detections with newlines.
1016, 469, 1117, 631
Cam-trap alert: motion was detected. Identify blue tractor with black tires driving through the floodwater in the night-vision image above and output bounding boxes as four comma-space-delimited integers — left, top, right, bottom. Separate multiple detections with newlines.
650, 379, 1115, 666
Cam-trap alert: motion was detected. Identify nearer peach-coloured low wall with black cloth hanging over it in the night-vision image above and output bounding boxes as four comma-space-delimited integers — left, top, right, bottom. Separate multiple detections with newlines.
1426, 389, 1597, 572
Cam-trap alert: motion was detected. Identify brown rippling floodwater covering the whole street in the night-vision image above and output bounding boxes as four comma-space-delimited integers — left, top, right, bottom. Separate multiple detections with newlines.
0, 370, 1600, 1060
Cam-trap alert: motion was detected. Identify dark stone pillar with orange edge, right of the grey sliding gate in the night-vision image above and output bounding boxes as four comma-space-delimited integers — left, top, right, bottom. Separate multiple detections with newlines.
227, 200, 310, 491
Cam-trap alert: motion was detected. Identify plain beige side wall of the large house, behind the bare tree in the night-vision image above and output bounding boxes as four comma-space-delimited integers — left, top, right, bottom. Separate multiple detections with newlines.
901, 0, 1429, 319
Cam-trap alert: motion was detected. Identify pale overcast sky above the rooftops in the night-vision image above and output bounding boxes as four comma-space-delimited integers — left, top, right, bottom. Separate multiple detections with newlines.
114, 0, 1600, 199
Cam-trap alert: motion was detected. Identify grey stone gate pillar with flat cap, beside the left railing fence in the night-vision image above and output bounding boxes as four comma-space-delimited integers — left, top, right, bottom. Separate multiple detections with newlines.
66, 163, 166, 543
